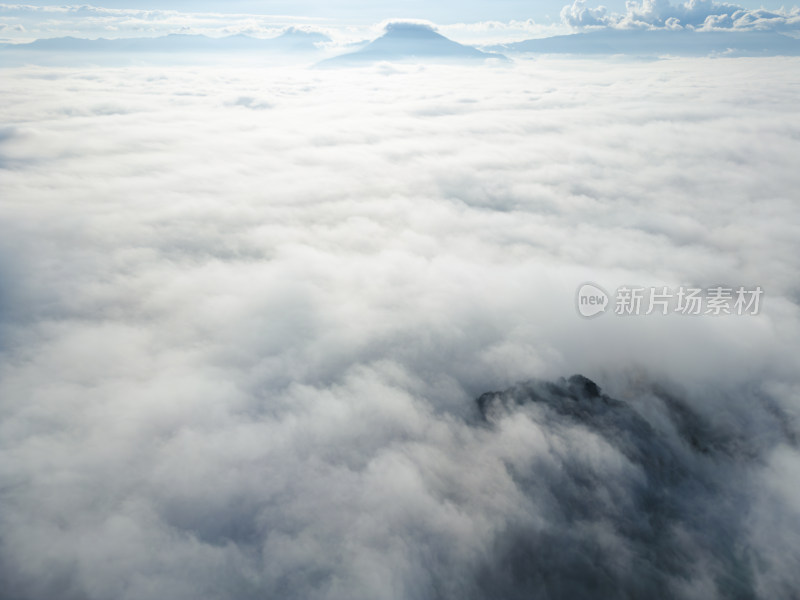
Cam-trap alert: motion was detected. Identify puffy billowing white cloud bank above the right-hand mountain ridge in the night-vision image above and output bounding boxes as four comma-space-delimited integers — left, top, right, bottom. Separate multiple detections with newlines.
561, 0, 800, 31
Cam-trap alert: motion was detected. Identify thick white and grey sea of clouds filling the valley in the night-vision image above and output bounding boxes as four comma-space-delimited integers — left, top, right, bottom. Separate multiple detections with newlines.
0, 58, 800, 600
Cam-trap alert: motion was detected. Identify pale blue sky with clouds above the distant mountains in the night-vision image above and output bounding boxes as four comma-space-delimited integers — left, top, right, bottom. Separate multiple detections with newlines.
0, 0, 800, 44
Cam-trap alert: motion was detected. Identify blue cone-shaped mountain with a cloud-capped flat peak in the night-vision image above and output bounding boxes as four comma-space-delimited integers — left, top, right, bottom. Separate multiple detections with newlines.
320, 23, 508, 66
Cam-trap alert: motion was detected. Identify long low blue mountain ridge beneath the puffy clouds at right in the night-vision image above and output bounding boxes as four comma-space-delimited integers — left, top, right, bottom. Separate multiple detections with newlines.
488, 29, 800, 56
